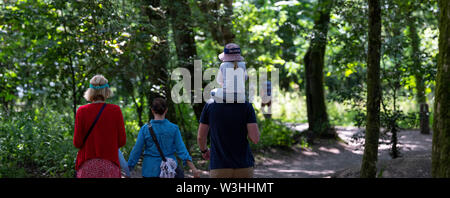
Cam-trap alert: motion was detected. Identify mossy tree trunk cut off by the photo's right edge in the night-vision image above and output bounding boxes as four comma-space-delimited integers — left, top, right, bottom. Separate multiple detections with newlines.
431, 0, 450, 178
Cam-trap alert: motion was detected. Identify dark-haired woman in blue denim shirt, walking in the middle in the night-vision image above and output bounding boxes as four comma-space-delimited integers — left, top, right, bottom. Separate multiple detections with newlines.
128, 98, 200, 178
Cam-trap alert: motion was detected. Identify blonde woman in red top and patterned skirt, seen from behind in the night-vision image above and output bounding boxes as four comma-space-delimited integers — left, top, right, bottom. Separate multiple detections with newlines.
73, 75, 126, 178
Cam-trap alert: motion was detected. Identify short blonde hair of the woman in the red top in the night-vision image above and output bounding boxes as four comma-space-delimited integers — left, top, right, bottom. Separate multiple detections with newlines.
83, 75, 113, 102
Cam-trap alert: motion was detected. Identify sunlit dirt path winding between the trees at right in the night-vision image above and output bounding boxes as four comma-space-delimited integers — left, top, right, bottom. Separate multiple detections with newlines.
255, 127, 432, 178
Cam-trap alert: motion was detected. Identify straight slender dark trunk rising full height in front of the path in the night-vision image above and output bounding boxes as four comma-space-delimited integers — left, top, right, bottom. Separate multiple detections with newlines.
361, 0, 381, 178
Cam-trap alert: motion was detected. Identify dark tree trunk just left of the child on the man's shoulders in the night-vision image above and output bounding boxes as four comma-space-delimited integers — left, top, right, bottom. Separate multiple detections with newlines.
167, 0, 204, 120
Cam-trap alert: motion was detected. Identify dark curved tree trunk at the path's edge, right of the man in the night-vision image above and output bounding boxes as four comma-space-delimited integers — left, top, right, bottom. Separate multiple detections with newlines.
304, 0, 336, 138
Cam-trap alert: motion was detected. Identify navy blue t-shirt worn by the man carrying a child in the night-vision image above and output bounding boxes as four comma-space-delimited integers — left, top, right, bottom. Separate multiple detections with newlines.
200, 101, 256, 169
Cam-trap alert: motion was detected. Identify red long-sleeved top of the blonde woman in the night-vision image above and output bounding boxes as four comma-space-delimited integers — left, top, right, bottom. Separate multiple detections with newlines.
73, 103, 126, 170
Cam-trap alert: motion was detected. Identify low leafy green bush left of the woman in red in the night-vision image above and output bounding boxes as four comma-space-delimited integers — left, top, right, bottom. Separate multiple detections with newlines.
0, 108, 77, 177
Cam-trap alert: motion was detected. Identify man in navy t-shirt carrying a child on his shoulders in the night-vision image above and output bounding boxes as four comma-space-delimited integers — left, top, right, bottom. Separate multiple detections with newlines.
197, 99, 260, 178
